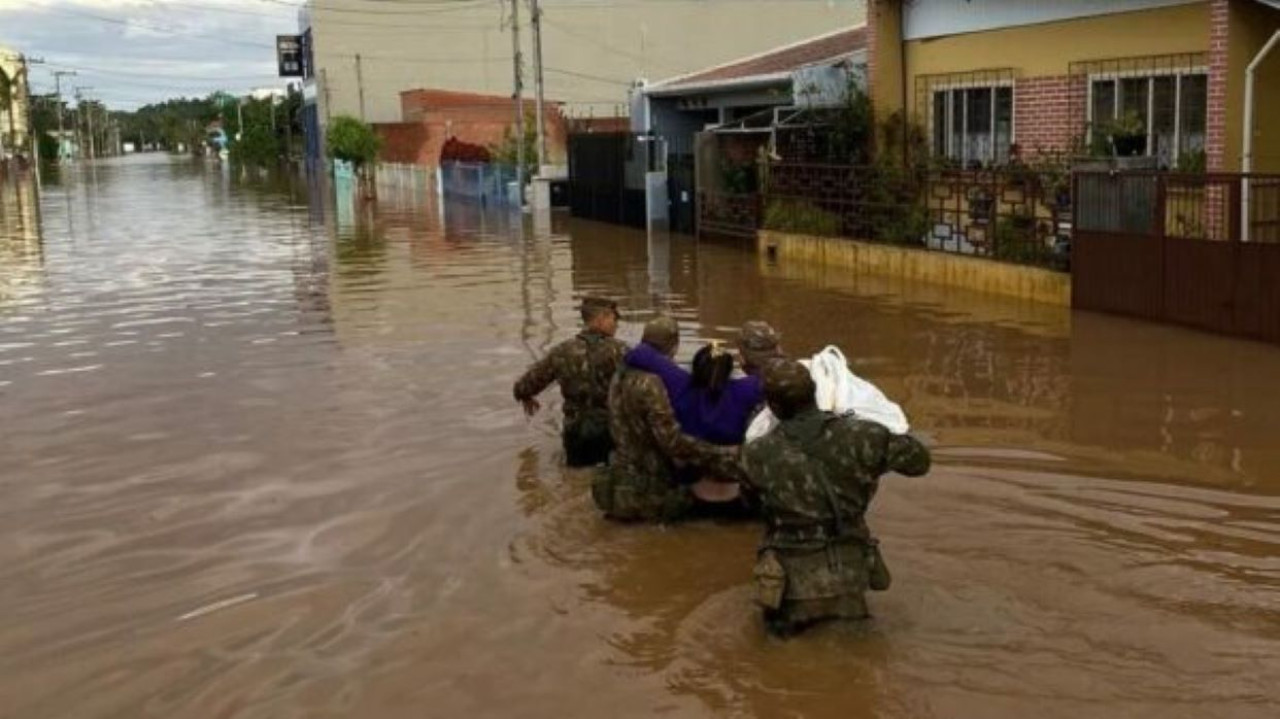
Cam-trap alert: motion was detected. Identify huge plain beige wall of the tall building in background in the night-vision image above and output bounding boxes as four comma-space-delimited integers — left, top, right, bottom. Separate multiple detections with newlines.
310, 0, 865, 122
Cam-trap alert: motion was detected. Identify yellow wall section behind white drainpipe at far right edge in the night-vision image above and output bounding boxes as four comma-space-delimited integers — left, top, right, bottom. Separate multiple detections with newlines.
1222, 1, 1280, 173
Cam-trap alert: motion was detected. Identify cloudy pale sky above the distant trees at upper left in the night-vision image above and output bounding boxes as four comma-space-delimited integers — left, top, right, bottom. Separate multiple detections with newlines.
0, 0, 301, 110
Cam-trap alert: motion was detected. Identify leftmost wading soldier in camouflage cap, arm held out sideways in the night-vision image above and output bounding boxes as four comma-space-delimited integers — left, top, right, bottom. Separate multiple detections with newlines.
513, 297, 627, 467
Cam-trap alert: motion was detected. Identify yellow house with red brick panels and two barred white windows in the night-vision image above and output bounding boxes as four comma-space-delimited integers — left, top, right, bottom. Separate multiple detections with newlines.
867, 0, 1280, 171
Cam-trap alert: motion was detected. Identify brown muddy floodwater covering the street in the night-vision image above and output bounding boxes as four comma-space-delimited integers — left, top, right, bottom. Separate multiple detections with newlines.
0, 157, 1280, 719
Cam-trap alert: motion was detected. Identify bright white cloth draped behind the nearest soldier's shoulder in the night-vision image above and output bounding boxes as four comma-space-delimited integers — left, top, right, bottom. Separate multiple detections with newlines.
746, 345, 911, 441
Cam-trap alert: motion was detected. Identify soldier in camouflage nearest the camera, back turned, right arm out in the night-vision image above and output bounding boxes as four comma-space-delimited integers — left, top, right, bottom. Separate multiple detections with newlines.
742, 361, 931, 635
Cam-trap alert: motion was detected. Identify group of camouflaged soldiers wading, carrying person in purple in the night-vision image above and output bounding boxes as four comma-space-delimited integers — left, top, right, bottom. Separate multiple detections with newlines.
515, 297, 931, 635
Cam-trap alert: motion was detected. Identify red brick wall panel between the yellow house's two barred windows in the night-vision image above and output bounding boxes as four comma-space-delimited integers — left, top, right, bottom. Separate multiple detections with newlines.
1014, 75, 1085, 156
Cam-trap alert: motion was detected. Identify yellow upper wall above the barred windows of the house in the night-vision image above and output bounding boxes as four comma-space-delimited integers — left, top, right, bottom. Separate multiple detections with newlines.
906, 3, 1208, 114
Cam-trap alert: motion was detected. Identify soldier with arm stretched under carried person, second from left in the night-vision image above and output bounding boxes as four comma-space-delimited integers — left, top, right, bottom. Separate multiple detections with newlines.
591, 317, 741, 522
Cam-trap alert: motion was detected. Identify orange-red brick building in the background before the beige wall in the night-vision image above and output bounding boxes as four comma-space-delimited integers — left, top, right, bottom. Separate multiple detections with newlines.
374, 90, 566, 168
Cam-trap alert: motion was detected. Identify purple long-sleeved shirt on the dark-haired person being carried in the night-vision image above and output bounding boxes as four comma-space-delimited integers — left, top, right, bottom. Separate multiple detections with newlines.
626, 343, 764, 445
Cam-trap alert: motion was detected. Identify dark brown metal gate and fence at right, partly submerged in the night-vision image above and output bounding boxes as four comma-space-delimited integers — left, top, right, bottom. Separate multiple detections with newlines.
1071, 173, 1280, 343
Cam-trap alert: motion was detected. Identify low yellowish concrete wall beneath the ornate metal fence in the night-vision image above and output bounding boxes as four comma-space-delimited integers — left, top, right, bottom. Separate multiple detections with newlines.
758, 230, 1071, 307
